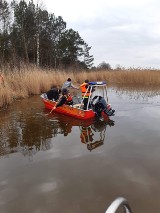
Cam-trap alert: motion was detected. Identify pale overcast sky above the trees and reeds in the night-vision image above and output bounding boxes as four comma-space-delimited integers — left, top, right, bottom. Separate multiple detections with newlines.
39, 0, 160, 69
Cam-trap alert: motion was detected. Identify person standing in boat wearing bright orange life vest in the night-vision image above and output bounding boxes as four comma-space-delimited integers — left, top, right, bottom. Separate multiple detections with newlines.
80, 79, 94, 110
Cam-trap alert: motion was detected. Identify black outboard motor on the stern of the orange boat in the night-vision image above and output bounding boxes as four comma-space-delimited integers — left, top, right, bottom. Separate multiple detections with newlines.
92, 96, 115, 117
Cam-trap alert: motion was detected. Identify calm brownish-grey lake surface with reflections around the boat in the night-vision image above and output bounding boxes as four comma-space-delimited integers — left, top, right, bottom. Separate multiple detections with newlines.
0, 90, 160, 213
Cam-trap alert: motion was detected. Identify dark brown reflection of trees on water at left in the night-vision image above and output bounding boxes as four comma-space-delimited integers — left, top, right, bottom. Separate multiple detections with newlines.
0, 109, 56, 155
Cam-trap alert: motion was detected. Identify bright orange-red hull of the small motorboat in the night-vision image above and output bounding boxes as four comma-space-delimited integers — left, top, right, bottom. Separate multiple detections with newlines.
42, 98, 95, 120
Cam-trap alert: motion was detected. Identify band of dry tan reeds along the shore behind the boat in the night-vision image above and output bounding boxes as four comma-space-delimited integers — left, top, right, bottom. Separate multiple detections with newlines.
0, 65, 160, 107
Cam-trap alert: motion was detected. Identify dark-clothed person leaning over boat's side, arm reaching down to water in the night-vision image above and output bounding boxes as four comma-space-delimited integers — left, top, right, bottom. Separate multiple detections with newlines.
53, 88, 73, 110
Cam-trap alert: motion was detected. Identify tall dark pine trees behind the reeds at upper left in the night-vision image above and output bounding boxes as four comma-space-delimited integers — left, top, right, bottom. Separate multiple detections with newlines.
0, 0, 94, 69
